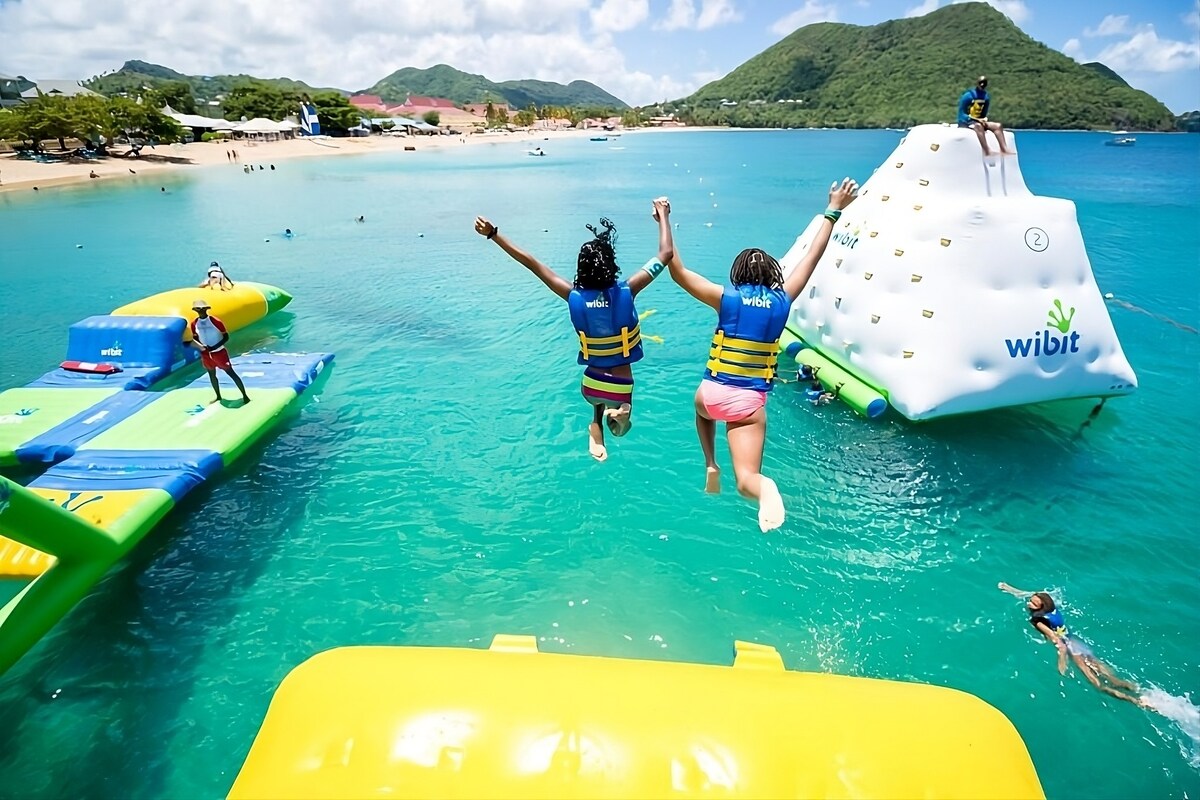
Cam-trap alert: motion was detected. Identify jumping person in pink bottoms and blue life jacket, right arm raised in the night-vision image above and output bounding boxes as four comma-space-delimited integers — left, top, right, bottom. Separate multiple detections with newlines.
667, 178, 858, 533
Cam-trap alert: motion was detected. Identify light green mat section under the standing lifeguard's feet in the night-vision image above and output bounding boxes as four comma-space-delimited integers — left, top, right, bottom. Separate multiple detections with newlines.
79, 389, 296, 464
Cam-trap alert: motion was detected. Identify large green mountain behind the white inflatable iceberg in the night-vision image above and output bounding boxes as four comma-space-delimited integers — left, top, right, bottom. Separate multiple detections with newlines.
662, 2, 1176, 131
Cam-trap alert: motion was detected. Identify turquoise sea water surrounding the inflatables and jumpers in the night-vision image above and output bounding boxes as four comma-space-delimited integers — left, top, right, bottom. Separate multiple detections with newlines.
0, 131, 1200, 798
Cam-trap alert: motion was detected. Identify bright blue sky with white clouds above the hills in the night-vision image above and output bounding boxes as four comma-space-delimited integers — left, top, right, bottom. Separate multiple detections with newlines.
0, 0, 1200, 113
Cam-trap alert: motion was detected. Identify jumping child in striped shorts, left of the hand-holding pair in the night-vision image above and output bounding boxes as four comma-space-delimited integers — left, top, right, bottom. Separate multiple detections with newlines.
475, 198, 674, 462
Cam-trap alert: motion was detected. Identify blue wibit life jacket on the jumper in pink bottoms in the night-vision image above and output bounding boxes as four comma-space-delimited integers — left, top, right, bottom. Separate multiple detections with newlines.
704, 284, 792, 392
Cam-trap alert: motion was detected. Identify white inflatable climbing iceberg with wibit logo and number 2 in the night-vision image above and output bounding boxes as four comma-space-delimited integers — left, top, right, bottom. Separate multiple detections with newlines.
780, 125, 1138, 420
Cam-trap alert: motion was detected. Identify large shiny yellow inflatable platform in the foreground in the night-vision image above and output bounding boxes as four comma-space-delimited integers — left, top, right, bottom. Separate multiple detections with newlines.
229, 634, 1044, 800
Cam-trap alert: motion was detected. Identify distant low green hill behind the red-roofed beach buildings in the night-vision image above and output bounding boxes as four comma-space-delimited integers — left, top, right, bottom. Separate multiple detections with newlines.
362, 64, 629, 109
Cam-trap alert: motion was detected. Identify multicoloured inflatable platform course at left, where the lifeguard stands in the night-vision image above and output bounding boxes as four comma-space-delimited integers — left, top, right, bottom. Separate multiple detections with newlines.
0, 282, 334, 673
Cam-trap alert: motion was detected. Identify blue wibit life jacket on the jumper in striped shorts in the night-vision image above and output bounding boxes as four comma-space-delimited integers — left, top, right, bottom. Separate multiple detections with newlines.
566, 281, 642, 367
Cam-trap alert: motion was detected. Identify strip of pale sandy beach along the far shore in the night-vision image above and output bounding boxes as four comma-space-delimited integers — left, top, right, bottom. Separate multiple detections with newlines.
0, 130, 619, 192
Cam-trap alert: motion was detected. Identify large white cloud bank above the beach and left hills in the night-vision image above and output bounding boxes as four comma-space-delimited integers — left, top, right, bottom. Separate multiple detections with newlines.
0, 0, 705, 104
